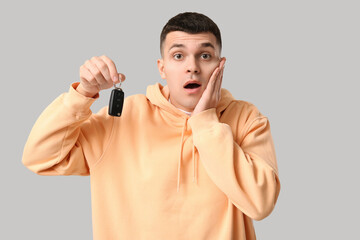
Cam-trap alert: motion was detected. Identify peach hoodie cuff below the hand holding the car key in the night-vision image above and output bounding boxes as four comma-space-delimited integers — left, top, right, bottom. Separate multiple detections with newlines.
64, 82, 99, 114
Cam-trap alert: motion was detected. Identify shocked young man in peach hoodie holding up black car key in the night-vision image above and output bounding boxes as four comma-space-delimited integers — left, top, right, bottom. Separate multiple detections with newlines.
23, 13, 280, 240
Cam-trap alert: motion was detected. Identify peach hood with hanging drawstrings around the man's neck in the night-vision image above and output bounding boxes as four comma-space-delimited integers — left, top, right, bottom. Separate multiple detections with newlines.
146, 83, 235, 192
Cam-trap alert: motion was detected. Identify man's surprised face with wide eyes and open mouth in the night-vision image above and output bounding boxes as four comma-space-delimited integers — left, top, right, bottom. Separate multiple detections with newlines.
158, 31, 221, 112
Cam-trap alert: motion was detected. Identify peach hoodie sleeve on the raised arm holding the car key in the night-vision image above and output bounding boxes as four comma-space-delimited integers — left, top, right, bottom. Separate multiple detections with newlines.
22, 83, 113, 175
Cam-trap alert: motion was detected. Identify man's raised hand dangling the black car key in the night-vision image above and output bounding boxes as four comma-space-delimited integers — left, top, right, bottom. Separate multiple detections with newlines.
76, 55, 125, 97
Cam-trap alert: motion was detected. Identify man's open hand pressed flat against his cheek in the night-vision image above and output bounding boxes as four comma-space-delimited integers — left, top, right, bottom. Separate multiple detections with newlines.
191, 57, 226, 116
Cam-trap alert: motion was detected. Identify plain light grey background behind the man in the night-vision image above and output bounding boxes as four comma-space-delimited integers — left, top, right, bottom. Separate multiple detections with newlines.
0, 0, 360, 239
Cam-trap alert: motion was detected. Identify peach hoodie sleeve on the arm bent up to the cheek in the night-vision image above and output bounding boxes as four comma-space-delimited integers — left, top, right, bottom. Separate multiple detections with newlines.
189, 108, 280, 220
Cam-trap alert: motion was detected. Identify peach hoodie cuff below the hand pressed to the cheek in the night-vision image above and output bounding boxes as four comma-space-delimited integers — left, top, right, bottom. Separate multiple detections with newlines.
188, 108, 219, 132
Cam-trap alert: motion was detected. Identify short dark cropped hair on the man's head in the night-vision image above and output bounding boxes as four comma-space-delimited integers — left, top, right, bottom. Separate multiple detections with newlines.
160, 12, 222, 54
